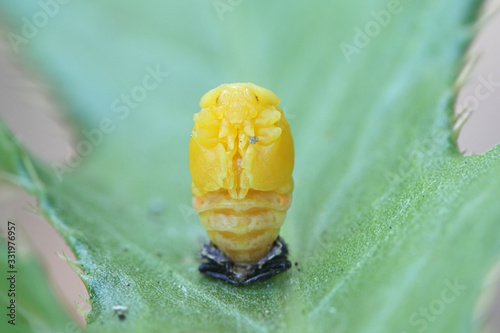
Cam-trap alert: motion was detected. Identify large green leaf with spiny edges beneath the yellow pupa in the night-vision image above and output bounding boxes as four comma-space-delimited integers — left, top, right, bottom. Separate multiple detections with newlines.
0, 0, 500, 332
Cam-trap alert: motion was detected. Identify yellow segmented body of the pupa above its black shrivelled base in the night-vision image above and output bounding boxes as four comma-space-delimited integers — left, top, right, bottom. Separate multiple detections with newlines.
189, 83, 294, 263
